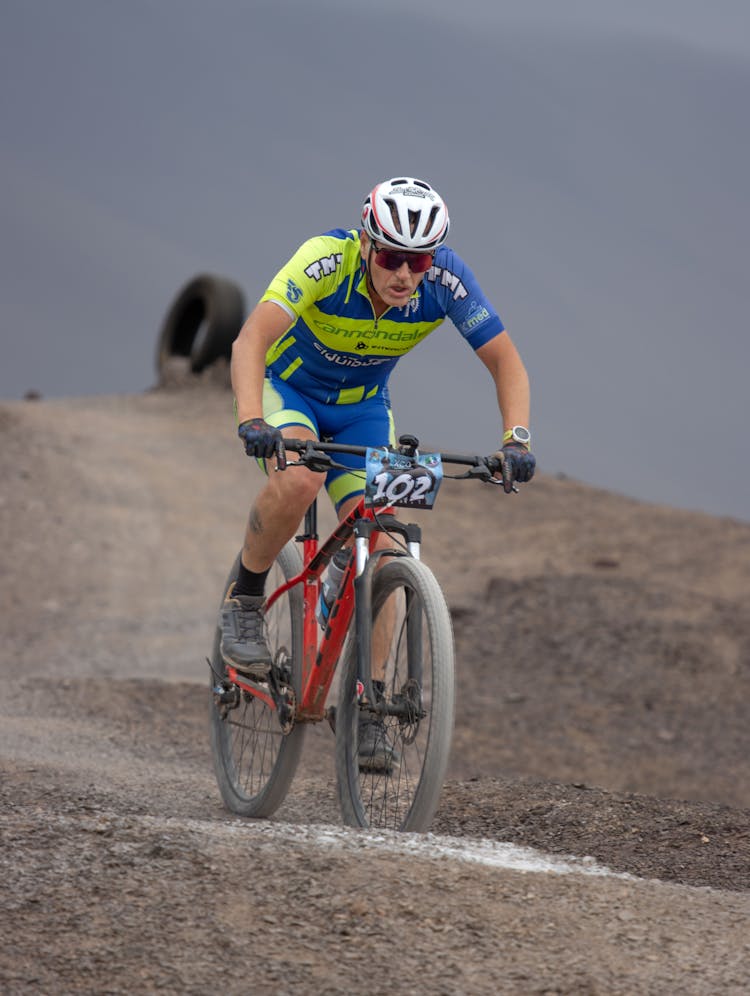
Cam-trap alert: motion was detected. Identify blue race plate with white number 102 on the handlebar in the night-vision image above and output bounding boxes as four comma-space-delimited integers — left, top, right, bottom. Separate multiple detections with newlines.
365, 448, 443, 508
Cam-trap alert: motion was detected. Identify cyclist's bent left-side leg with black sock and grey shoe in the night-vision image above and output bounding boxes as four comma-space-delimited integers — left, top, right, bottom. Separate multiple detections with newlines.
221, 426, 325, 679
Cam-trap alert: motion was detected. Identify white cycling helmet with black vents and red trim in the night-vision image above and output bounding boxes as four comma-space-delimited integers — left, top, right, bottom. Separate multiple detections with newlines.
362, 176, 450, 252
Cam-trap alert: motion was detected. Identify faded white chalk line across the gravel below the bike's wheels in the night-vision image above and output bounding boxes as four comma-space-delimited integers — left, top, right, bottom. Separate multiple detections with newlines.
5, 810, 638, 882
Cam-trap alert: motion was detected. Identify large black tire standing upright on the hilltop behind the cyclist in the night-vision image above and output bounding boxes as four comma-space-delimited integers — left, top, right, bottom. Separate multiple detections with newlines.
156, 273, 245, 377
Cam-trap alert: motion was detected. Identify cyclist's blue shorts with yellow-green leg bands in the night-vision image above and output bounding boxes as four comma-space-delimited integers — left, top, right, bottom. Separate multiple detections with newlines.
259, 375, 396, 511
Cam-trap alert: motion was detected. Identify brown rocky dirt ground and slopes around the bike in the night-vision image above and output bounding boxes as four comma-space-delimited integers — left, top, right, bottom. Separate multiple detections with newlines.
0, 383, 750, 994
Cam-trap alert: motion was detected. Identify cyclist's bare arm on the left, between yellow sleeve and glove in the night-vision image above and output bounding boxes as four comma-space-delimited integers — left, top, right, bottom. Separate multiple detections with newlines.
230, 301, 292, 424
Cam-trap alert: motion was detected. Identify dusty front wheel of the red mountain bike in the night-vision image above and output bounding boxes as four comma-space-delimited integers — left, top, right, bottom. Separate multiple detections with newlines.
336, 557, 455, 832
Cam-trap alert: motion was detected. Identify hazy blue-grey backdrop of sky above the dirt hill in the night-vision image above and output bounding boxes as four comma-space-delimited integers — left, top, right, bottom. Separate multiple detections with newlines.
0, 0, 750, 518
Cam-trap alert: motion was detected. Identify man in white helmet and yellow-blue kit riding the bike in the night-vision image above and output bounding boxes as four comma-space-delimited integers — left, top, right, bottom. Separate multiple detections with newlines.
220, 177, 535, 692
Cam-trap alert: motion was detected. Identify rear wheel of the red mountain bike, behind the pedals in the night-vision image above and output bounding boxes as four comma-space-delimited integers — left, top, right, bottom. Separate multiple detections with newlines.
210, 542, 305, 817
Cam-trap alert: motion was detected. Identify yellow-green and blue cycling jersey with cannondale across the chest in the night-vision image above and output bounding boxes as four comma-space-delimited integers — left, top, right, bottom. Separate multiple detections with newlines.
261, 229, 504, 404
